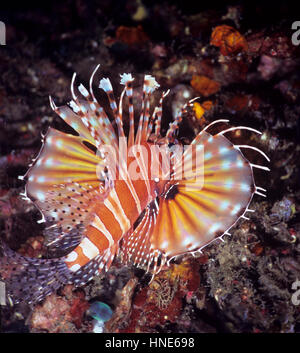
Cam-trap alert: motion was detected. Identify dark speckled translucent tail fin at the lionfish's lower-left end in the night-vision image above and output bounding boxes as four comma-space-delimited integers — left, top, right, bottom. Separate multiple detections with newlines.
0, 241, 115, 304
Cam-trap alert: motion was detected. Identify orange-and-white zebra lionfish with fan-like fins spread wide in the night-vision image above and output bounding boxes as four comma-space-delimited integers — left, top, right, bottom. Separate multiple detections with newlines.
0, 65, 269, 303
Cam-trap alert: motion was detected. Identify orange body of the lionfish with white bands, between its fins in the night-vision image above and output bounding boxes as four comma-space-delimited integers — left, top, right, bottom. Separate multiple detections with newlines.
65, 175, 155, 271
